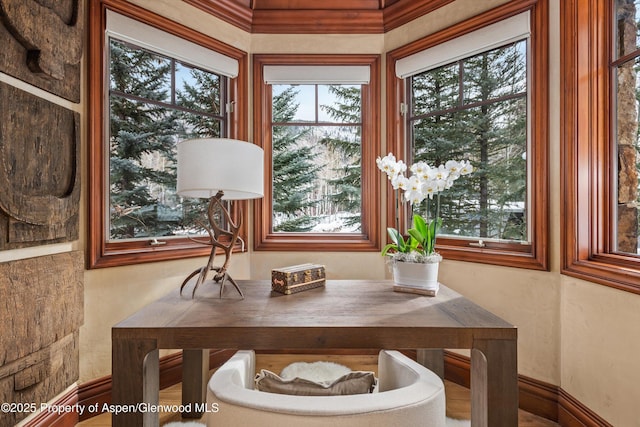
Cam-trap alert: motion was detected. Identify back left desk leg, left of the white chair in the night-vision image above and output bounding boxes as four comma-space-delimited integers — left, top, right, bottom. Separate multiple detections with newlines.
182, 349, 209, 418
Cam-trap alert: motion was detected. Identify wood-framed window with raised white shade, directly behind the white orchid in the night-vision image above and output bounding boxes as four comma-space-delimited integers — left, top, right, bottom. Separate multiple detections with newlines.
387, 0, 548, 270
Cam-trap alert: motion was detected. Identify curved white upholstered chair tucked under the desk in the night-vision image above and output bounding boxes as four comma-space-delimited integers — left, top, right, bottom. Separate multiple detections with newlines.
207, 350, 445, 427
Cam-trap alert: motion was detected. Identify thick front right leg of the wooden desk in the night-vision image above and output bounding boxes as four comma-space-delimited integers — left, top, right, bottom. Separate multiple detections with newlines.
471, 340, 518, 427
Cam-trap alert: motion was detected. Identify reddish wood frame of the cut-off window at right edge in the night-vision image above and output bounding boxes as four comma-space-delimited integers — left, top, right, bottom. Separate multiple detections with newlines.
560, 0, 640, 294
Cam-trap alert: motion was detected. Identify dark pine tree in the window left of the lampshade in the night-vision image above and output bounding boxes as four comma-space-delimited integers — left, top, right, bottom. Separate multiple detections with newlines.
109, 40, 176, 239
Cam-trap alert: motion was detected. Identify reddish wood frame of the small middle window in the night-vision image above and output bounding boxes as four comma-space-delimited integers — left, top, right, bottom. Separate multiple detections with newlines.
253, 54, 380, 252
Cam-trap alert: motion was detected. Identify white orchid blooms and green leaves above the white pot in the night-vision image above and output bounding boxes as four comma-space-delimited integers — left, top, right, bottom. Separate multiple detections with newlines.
376, 153, 473, 263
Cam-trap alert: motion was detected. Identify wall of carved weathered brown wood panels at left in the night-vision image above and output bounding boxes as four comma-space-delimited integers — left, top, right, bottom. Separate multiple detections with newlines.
0, 0, 87, 426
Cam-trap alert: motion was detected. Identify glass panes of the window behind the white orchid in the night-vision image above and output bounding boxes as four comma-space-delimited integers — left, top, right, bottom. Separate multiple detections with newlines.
406, 40, 530, 244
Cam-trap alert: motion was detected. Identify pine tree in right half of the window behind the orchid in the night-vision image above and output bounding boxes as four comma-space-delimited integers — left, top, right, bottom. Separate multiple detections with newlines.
464, 42, 527, 240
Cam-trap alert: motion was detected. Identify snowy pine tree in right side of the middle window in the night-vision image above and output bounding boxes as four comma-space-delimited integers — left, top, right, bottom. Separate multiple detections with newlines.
320, 85, 362, 228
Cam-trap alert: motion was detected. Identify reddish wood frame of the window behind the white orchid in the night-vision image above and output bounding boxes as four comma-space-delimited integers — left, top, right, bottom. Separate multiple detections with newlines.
386, 0, 549, 270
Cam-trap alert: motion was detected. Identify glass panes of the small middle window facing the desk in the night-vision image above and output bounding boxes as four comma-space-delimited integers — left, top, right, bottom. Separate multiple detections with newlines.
271, 84, 362, 233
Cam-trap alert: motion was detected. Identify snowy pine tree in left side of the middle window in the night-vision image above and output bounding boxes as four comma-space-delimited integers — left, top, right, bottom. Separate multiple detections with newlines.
272, 87, 321, 232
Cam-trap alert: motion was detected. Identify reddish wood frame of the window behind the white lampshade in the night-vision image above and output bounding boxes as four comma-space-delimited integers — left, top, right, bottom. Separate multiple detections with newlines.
87, 0, 248, 268
